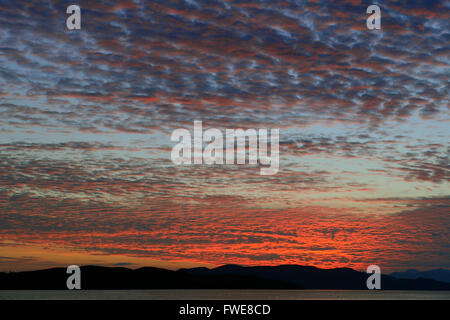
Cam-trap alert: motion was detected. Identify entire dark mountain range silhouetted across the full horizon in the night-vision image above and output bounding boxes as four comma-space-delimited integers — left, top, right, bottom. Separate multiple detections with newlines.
0, 265, 450, 290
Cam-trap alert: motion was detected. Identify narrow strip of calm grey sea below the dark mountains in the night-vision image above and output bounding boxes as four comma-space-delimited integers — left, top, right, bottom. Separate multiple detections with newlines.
0, 290, 450, 300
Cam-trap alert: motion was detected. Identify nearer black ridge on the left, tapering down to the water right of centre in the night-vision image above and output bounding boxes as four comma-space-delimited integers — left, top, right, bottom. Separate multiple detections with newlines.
0, 266, 302, 290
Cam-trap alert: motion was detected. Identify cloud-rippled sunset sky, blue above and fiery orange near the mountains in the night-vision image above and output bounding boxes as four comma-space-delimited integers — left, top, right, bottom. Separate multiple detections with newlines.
0, 0, 450, 272
